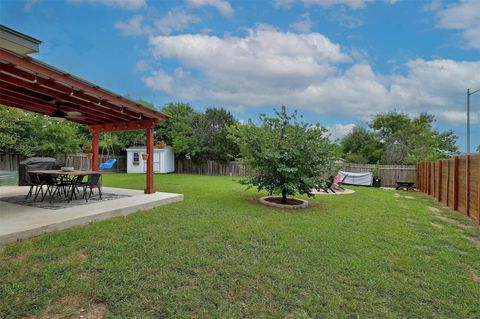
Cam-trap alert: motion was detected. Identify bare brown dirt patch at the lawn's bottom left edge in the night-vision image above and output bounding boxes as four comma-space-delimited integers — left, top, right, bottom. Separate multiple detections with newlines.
24, 296, 107, 319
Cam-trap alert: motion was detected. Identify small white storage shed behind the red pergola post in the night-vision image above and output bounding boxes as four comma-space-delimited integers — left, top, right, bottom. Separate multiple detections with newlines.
127, 146, 175, 173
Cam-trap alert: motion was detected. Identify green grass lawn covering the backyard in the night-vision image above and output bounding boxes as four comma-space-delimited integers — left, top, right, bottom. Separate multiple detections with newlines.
0, 174, 480, 318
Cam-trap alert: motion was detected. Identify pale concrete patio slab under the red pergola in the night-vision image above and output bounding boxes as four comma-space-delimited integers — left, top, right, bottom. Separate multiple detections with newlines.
0, 186, 183, 244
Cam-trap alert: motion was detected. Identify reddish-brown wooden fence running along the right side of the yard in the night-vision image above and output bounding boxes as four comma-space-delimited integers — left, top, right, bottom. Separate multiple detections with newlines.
417, 155, 480, 224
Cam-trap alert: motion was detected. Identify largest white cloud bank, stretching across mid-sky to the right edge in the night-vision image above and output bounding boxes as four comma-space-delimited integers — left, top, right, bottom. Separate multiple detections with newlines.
144, 26, 480, 122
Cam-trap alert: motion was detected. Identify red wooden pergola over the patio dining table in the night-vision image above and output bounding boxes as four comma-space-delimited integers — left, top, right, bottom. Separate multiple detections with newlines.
0, 48, 168, 194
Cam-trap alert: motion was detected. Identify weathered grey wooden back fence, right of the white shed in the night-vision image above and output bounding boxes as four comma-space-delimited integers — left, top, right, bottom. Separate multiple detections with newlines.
175, 159, 416, 186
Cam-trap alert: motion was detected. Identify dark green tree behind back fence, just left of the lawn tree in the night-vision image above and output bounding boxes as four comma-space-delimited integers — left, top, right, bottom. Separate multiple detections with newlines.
193, 108, 240, 163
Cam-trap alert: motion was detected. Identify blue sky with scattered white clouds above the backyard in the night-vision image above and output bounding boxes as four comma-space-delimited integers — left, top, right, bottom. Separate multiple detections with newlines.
0, 0, 480, 151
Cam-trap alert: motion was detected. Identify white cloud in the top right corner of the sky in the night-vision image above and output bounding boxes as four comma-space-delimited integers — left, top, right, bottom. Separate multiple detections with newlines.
431, 0, 480, 49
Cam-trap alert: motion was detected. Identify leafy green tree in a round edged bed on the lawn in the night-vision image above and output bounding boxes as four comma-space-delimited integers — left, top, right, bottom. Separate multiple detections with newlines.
228, 106, 334, 203
